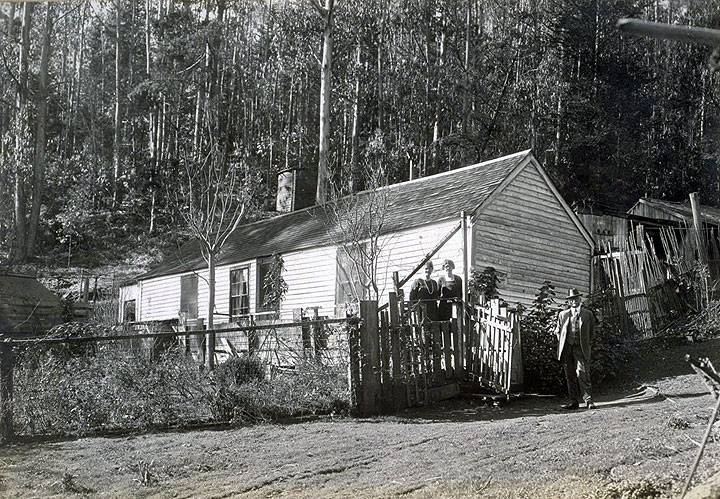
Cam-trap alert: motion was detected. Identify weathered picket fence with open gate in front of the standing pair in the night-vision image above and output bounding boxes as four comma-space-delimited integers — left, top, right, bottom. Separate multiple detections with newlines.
350, 293, 522, 414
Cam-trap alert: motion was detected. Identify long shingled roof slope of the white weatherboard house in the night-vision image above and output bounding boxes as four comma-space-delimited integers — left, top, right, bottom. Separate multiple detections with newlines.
138, 150, 532, 280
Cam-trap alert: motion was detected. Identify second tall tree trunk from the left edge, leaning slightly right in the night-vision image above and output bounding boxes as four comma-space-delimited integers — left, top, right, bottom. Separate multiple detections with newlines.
27, 3, 53, 258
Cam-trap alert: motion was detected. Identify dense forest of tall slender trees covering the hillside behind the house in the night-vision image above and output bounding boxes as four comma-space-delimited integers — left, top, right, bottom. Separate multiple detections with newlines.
0, 0, 720, 270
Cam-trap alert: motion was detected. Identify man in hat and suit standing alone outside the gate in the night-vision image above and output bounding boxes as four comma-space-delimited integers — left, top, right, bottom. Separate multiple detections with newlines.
555, 289, 595, 410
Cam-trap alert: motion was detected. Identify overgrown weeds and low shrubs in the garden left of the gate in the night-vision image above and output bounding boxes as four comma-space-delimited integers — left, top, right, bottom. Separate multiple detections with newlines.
14, 340, 349, 435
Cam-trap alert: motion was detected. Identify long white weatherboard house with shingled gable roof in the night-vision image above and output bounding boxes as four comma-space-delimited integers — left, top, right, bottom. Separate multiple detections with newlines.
120, 151, 594, 323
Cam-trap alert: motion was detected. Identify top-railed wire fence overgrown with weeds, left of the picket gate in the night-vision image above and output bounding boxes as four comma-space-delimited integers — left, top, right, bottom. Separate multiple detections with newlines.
0, 320, 350, 437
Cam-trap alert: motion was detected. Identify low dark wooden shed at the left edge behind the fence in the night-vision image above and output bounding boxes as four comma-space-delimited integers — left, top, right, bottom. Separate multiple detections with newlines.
0, 274, 62, 334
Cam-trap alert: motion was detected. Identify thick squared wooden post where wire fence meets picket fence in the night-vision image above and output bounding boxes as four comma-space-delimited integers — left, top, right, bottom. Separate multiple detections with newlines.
360, 301, 380, 415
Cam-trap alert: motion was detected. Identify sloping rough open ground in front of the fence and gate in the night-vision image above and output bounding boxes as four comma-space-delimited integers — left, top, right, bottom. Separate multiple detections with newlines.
0, 340, 720, 498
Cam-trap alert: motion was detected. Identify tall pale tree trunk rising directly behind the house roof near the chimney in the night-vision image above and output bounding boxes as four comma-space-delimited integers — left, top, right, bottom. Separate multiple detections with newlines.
315, 0, 335, 204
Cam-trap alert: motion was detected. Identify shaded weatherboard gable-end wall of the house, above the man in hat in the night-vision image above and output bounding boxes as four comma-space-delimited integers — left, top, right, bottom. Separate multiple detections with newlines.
472, 162, 592, 306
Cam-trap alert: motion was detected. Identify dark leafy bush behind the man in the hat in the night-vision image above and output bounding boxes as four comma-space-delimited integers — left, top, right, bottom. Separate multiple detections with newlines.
520, 281, 637, 394
